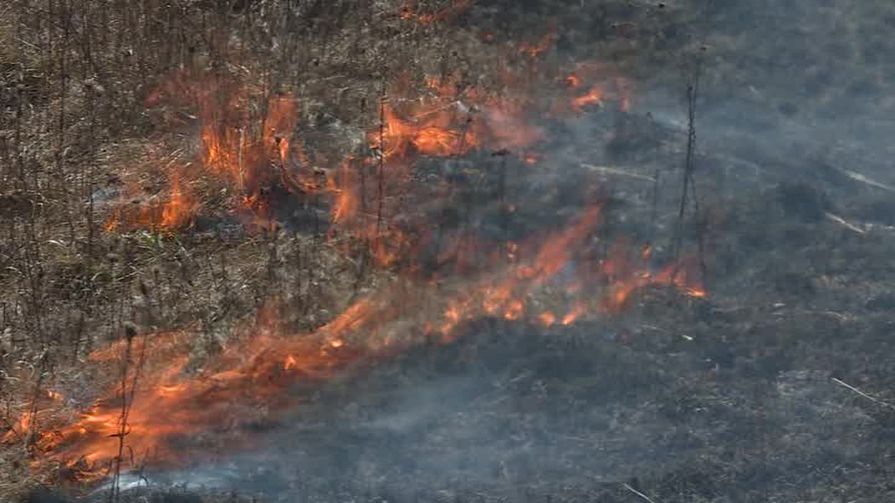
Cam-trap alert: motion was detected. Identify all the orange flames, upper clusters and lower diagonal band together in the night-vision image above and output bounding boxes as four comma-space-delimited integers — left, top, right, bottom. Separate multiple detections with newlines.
2, 30, 706, 488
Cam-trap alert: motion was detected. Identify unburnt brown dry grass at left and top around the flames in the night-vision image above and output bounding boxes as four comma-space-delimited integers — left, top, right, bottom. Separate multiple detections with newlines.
0, 0, 712, 501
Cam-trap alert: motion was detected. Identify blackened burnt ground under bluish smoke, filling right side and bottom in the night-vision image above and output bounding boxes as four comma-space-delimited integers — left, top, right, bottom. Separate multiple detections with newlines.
10, 0, 895, 502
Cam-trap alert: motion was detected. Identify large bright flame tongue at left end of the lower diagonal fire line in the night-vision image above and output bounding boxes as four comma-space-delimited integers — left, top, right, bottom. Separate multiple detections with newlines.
26, 324, 366, 480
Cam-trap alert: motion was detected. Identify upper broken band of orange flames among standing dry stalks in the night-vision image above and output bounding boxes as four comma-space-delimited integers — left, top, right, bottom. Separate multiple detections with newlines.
104, 47, 633, 237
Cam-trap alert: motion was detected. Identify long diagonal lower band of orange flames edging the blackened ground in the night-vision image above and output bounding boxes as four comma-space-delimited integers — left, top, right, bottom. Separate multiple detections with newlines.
3, 198, 704, 480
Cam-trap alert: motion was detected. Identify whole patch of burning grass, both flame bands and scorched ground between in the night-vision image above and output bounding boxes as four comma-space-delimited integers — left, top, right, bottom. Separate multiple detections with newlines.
3, 1, 705, 498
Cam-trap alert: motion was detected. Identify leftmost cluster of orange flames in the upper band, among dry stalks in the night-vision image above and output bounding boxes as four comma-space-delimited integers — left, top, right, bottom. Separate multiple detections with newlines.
105, 74, 321, 236
